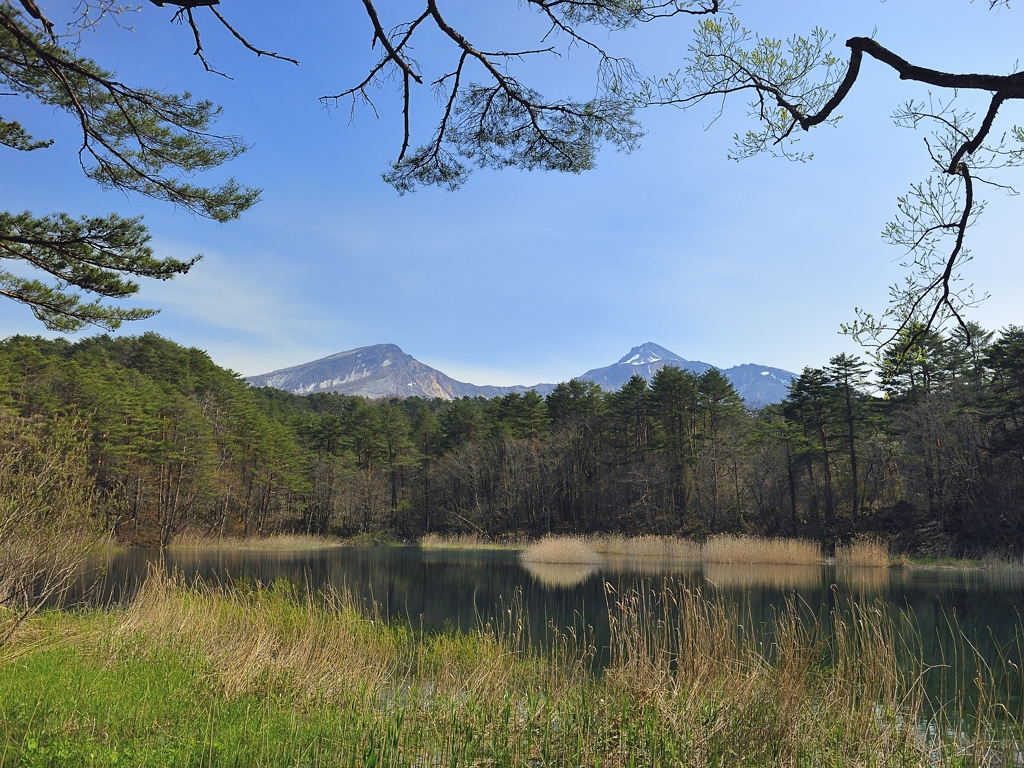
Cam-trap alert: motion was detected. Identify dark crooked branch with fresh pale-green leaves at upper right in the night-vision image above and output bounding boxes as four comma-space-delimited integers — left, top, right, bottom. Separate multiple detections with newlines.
641, 12, 1024, 354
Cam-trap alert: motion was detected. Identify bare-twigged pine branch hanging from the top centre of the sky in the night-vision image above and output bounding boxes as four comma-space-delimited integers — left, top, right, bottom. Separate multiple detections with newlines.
321, 0, 721, 193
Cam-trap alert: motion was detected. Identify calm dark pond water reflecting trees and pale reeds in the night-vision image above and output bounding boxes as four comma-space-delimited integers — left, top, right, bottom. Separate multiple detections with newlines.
86, 547, 1024, 679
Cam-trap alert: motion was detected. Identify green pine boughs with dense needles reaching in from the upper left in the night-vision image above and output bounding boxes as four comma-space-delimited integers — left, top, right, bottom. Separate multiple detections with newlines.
0, 6, 259, 332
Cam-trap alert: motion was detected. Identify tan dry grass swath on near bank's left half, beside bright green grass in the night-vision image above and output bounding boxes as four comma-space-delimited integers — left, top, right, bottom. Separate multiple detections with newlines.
117, 567, 561, 706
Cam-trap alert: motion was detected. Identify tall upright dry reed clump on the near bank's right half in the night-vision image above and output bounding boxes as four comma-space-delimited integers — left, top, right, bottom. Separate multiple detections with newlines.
608, 584, 927, 766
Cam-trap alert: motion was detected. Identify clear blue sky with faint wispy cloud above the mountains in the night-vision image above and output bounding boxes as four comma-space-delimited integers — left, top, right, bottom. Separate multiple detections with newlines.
0, 0, 1024, 385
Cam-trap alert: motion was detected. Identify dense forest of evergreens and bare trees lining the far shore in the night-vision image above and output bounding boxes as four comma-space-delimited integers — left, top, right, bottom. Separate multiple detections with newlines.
0, 328, 1024, 553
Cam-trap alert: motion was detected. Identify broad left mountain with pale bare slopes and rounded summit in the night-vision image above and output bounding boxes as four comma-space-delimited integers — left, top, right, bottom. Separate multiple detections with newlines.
249, 344, 553, 400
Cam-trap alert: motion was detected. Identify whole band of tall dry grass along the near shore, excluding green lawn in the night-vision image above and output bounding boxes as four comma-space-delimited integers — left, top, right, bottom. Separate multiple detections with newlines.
101, 572, 1019, 768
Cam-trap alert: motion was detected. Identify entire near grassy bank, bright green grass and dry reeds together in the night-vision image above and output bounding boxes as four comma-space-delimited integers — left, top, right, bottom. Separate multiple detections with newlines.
0, 574, 1013, 768
